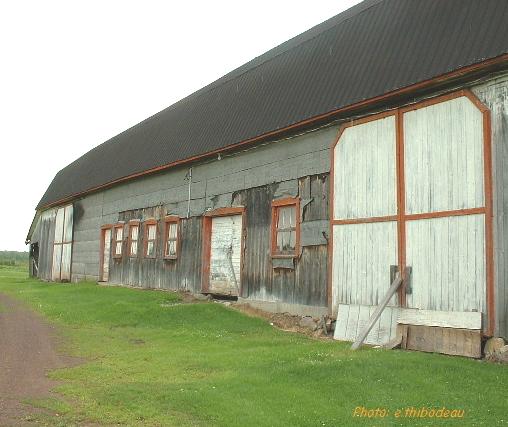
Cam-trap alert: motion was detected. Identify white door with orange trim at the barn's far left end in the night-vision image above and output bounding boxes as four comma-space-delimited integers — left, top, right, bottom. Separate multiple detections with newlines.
51, 205, 73, 281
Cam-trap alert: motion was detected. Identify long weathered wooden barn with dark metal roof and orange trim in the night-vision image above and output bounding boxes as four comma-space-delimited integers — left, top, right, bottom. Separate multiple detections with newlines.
27, 0, 508, 354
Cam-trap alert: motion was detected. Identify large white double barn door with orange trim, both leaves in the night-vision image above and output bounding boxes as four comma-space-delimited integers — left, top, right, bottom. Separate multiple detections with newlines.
331, 92, 493, 344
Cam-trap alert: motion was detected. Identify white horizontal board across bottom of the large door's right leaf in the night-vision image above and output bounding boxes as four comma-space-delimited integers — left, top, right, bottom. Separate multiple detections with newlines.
397, 308, 482, 329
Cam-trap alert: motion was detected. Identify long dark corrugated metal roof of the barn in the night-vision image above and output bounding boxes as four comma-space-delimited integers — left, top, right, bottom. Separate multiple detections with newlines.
38, 0, 508, 207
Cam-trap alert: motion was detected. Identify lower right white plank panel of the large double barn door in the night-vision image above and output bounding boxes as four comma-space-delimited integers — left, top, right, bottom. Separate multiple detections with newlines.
406, 215, 486, 313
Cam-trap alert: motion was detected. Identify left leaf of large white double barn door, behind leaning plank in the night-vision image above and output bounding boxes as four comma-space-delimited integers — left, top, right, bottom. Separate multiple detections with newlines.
332, 114, 398, 342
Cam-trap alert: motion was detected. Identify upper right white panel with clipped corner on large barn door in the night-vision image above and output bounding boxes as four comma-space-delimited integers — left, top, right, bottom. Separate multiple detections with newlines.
403, 97, 485, 214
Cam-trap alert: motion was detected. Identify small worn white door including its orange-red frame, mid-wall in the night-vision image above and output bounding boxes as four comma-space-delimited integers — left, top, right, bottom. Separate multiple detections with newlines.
202, 208, 244, 296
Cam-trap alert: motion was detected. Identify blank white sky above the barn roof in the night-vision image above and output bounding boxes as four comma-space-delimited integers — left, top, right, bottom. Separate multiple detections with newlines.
0, 0, 359, 250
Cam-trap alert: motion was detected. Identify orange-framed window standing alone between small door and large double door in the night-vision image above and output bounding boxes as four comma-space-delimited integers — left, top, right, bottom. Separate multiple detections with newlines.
271, 198, 300, 258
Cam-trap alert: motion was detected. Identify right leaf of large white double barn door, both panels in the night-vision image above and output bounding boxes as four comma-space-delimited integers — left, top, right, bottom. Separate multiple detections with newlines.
403, 96, 486, 313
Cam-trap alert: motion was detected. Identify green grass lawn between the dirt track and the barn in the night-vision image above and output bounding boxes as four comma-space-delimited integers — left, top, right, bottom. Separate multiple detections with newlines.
0, 268, 508, 426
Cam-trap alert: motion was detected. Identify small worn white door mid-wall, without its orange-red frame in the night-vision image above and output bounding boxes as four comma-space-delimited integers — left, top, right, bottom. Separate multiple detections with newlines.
208, 215, 242, 295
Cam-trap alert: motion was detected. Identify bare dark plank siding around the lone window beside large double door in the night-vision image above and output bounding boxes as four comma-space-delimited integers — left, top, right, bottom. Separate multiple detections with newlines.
240, 174, 329, 307
